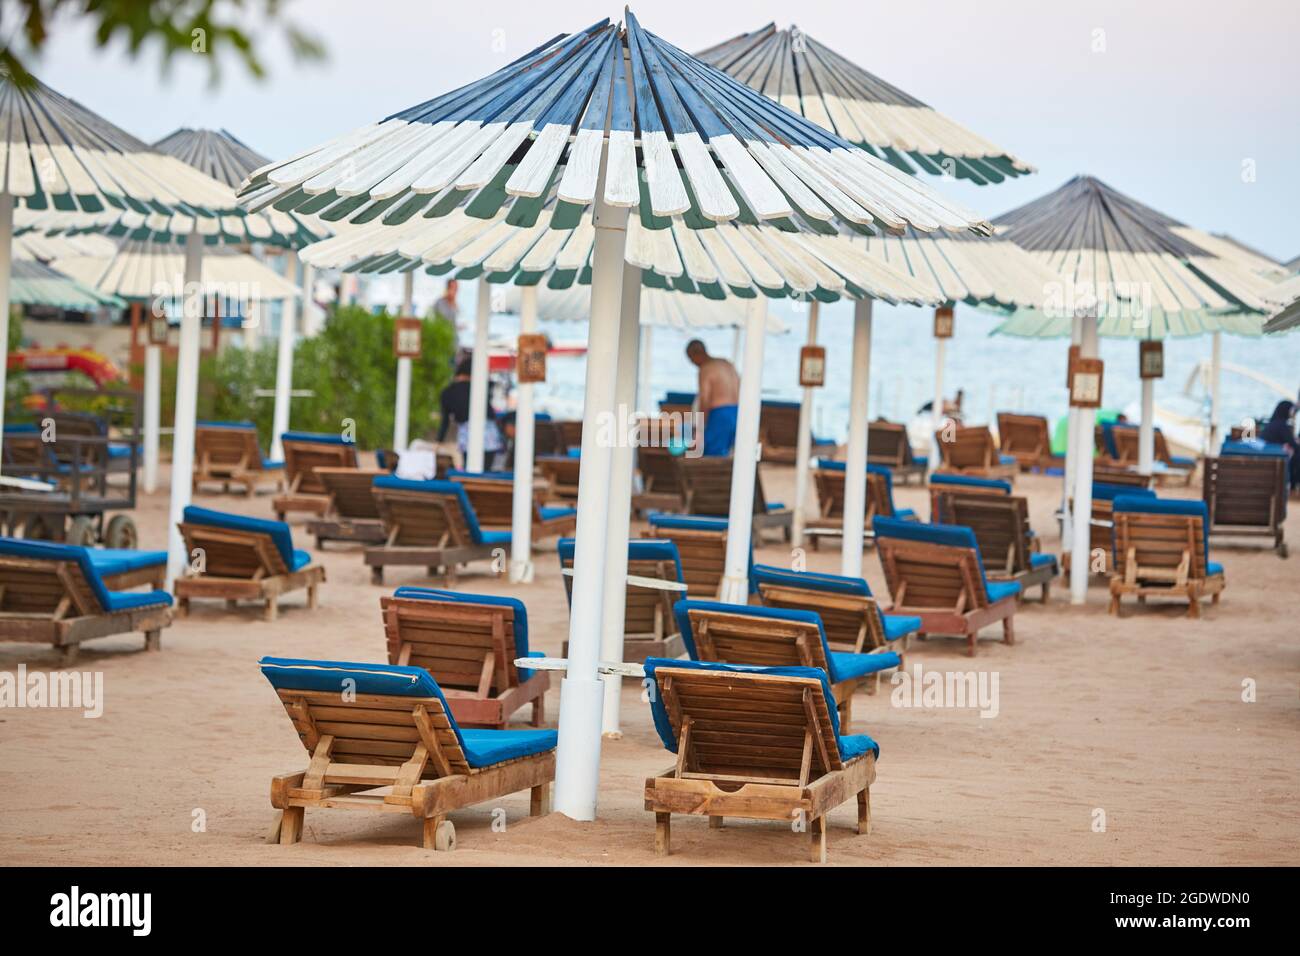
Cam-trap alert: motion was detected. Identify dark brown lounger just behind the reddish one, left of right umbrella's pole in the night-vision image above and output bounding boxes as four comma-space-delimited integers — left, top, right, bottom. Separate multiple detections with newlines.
946, 494, 1058, 604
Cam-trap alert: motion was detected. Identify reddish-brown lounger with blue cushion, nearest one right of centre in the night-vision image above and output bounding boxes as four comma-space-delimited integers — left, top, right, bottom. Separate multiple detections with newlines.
876, 518, 1019, 657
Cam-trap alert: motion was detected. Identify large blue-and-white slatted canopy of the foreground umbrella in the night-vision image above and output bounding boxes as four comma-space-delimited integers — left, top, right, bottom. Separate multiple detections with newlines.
241, 12, 987, 239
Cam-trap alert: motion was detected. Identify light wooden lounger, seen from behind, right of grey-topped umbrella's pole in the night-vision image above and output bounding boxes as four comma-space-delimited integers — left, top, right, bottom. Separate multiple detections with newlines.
1110, 497, 1225, 618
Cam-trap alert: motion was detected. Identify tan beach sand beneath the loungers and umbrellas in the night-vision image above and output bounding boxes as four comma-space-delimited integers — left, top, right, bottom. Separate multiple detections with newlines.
0, 467, 1300, 866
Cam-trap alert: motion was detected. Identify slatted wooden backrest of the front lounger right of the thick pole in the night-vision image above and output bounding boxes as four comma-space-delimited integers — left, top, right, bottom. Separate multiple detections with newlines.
655, 666, 844, 783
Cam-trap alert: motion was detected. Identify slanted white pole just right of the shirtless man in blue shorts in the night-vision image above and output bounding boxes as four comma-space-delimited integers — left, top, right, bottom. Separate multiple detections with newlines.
720, 294, 767, 604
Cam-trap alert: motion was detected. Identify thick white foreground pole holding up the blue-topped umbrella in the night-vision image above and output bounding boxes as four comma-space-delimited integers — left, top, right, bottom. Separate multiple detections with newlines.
555, 150, 628, 819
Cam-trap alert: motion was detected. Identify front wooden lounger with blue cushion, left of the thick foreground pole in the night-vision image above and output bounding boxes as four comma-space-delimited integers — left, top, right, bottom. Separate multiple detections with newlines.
261, 658, 555, 851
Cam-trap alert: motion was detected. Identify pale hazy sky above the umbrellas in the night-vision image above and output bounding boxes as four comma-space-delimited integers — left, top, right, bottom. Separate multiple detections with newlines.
17, 0, 1300, 260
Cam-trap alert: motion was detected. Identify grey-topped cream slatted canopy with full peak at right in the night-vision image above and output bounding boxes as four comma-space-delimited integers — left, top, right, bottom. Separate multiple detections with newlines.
995, 176, 1275, 338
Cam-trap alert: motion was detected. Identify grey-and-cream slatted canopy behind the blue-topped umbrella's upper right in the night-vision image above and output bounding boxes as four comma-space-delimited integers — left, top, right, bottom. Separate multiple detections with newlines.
696, 23, 1035, 185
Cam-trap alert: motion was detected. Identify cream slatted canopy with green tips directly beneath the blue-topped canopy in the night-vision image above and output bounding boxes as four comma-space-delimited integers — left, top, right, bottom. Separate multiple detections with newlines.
302, 209, 940, 304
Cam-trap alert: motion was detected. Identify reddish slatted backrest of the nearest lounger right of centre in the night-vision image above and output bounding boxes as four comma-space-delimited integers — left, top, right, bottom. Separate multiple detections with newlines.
876, 537, 988, 611
